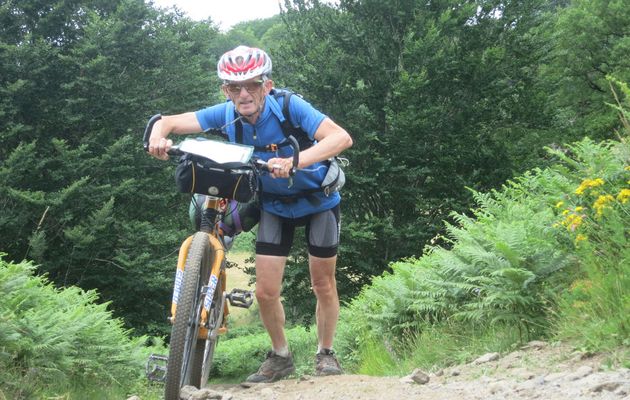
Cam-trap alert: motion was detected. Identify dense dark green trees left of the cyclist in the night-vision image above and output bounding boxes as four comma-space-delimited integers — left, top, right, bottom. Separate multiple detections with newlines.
0, 0, 221, 335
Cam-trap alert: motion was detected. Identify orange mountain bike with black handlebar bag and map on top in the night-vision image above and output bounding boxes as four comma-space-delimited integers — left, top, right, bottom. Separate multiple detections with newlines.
143, 115, 299, 400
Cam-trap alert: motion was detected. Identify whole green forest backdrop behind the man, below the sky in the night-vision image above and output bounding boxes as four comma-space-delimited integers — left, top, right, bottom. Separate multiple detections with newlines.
0, 0, 630, 398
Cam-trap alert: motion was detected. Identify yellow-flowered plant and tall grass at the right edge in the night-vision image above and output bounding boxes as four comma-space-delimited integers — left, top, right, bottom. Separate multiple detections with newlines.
557, 94, 630, 351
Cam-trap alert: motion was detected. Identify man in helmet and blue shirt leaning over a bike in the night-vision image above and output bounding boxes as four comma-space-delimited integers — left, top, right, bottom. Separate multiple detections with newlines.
149, 46, 352, 382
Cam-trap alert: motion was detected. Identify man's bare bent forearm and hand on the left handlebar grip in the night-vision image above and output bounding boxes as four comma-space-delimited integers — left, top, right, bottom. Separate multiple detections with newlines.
149, 112, 202, 160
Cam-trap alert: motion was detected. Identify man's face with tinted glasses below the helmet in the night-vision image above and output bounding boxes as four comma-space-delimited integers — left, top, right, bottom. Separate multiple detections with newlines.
222, 76, 273, 121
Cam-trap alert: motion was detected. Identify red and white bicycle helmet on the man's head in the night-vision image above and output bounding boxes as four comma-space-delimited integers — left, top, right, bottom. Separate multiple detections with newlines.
217, 46, 271, 82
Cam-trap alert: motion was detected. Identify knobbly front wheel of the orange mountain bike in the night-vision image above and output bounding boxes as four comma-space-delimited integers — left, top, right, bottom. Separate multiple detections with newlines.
164, 232, 214, 400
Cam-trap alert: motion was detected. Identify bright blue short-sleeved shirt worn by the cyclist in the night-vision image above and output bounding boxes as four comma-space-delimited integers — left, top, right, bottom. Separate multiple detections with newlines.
195, 95, 341, 218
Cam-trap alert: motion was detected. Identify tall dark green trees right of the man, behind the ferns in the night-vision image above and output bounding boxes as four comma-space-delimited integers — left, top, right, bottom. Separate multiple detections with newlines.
274, 0, 584, 322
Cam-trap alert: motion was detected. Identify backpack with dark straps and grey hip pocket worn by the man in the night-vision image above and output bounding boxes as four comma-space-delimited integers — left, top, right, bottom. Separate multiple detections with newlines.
234, 88, 346, 196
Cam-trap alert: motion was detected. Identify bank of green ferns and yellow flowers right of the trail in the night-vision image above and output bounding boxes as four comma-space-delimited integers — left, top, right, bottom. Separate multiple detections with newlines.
340, 122, 630, 368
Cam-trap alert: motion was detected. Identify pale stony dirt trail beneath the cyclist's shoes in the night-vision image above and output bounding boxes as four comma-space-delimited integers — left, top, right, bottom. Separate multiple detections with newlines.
169, 342, 630, 400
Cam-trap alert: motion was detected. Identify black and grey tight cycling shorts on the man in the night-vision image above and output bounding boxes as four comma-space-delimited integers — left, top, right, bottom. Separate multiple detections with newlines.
256, 204, 340, 258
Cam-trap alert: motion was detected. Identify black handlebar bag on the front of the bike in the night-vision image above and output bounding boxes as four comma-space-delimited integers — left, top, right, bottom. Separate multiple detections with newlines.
175, 154, 258, 203
